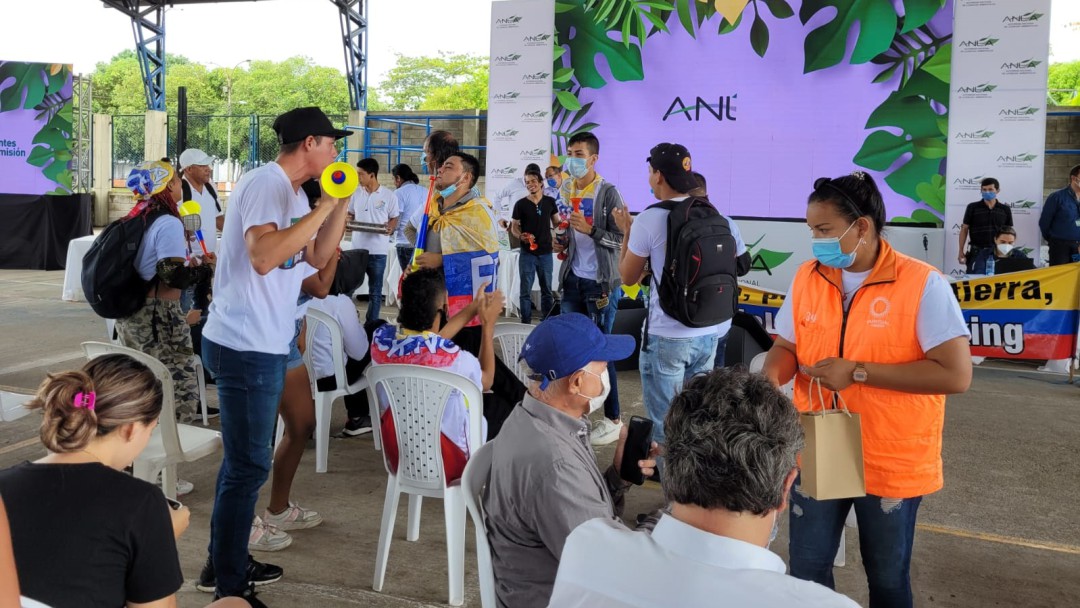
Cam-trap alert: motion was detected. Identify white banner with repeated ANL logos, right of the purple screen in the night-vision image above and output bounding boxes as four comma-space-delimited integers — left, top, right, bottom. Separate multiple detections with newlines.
945, 0, 1050, 274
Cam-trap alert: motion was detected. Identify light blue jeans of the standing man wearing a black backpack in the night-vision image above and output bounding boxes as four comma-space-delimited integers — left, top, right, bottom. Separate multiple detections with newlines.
637, 334, 716, 467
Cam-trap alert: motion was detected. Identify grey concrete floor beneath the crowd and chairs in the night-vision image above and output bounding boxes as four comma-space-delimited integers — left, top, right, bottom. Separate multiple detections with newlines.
0, 270, 1080, 608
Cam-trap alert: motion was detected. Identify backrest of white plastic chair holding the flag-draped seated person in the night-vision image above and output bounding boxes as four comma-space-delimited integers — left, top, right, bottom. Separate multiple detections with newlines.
364, 364, 484, 490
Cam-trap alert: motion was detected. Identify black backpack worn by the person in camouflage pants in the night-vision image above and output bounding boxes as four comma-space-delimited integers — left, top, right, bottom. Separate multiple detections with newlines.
82, 208, 166, 319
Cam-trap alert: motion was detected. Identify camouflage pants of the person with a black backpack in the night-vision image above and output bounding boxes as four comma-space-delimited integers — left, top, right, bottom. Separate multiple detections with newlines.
117, 298, 199, 422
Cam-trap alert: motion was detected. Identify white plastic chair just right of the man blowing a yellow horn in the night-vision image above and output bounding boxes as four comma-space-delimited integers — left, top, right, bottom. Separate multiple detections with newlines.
274, 308, 381, 473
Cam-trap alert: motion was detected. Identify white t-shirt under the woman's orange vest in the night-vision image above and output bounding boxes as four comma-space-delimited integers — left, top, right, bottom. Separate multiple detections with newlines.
773, 270, 970, 352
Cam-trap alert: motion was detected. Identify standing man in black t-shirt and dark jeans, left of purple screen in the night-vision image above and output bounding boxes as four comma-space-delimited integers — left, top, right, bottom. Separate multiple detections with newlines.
511, 171, 559, 323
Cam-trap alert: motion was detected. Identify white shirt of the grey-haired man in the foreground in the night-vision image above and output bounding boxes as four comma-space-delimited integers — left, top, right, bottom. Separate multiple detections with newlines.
549, 515, 859, 608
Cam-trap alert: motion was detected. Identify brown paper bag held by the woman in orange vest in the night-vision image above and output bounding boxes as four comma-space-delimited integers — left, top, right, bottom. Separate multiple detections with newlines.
799, 378, 866, 500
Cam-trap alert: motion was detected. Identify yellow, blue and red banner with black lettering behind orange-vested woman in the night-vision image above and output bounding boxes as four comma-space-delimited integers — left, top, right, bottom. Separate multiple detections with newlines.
739, 264, 1080, 361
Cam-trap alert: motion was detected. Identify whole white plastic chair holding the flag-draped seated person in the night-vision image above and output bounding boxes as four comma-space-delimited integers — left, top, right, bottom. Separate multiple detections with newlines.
365, 364, 484, 606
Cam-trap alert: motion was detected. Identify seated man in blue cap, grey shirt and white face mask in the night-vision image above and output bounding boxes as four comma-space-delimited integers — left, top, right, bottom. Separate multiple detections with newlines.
484, 313, 653, 608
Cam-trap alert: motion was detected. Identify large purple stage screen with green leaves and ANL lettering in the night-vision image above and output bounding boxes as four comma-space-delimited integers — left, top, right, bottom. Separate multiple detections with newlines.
553, 0, 953, 221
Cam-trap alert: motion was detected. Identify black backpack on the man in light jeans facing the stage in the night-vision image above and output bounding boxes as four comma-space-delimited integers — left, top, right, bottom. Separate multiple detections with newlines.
648, 197, 739, 327
